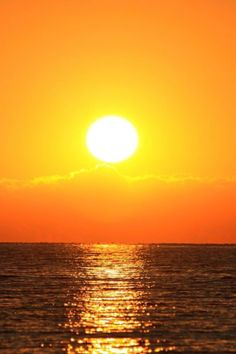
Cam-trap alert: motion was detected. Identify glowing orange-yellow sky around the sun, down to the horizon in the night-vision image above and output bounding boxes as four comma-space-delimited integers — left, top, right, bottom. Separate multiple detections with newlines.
0, 0, 236, 242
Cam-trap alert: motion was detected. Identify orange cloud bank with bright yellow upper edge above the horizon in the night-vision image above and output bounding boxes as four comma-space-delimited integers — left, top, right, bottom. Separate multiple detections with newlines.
0, 164, 236, 242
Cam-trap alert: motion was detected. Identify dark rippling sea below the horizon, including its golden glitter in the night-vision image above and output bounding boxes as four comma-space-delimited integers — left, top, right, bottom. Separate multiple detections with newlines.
0, 244, 236, 354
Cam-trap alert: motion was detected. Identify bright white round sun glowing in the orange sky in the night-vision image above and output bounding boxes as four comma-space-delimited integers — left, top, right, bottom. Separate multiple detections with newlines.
86, 116, 138, 163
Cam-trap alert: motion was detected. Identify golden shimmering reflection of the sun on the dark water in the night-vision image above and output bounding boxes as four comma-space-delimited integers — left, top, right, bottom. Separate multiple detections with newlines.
61, 245, 175, 354
